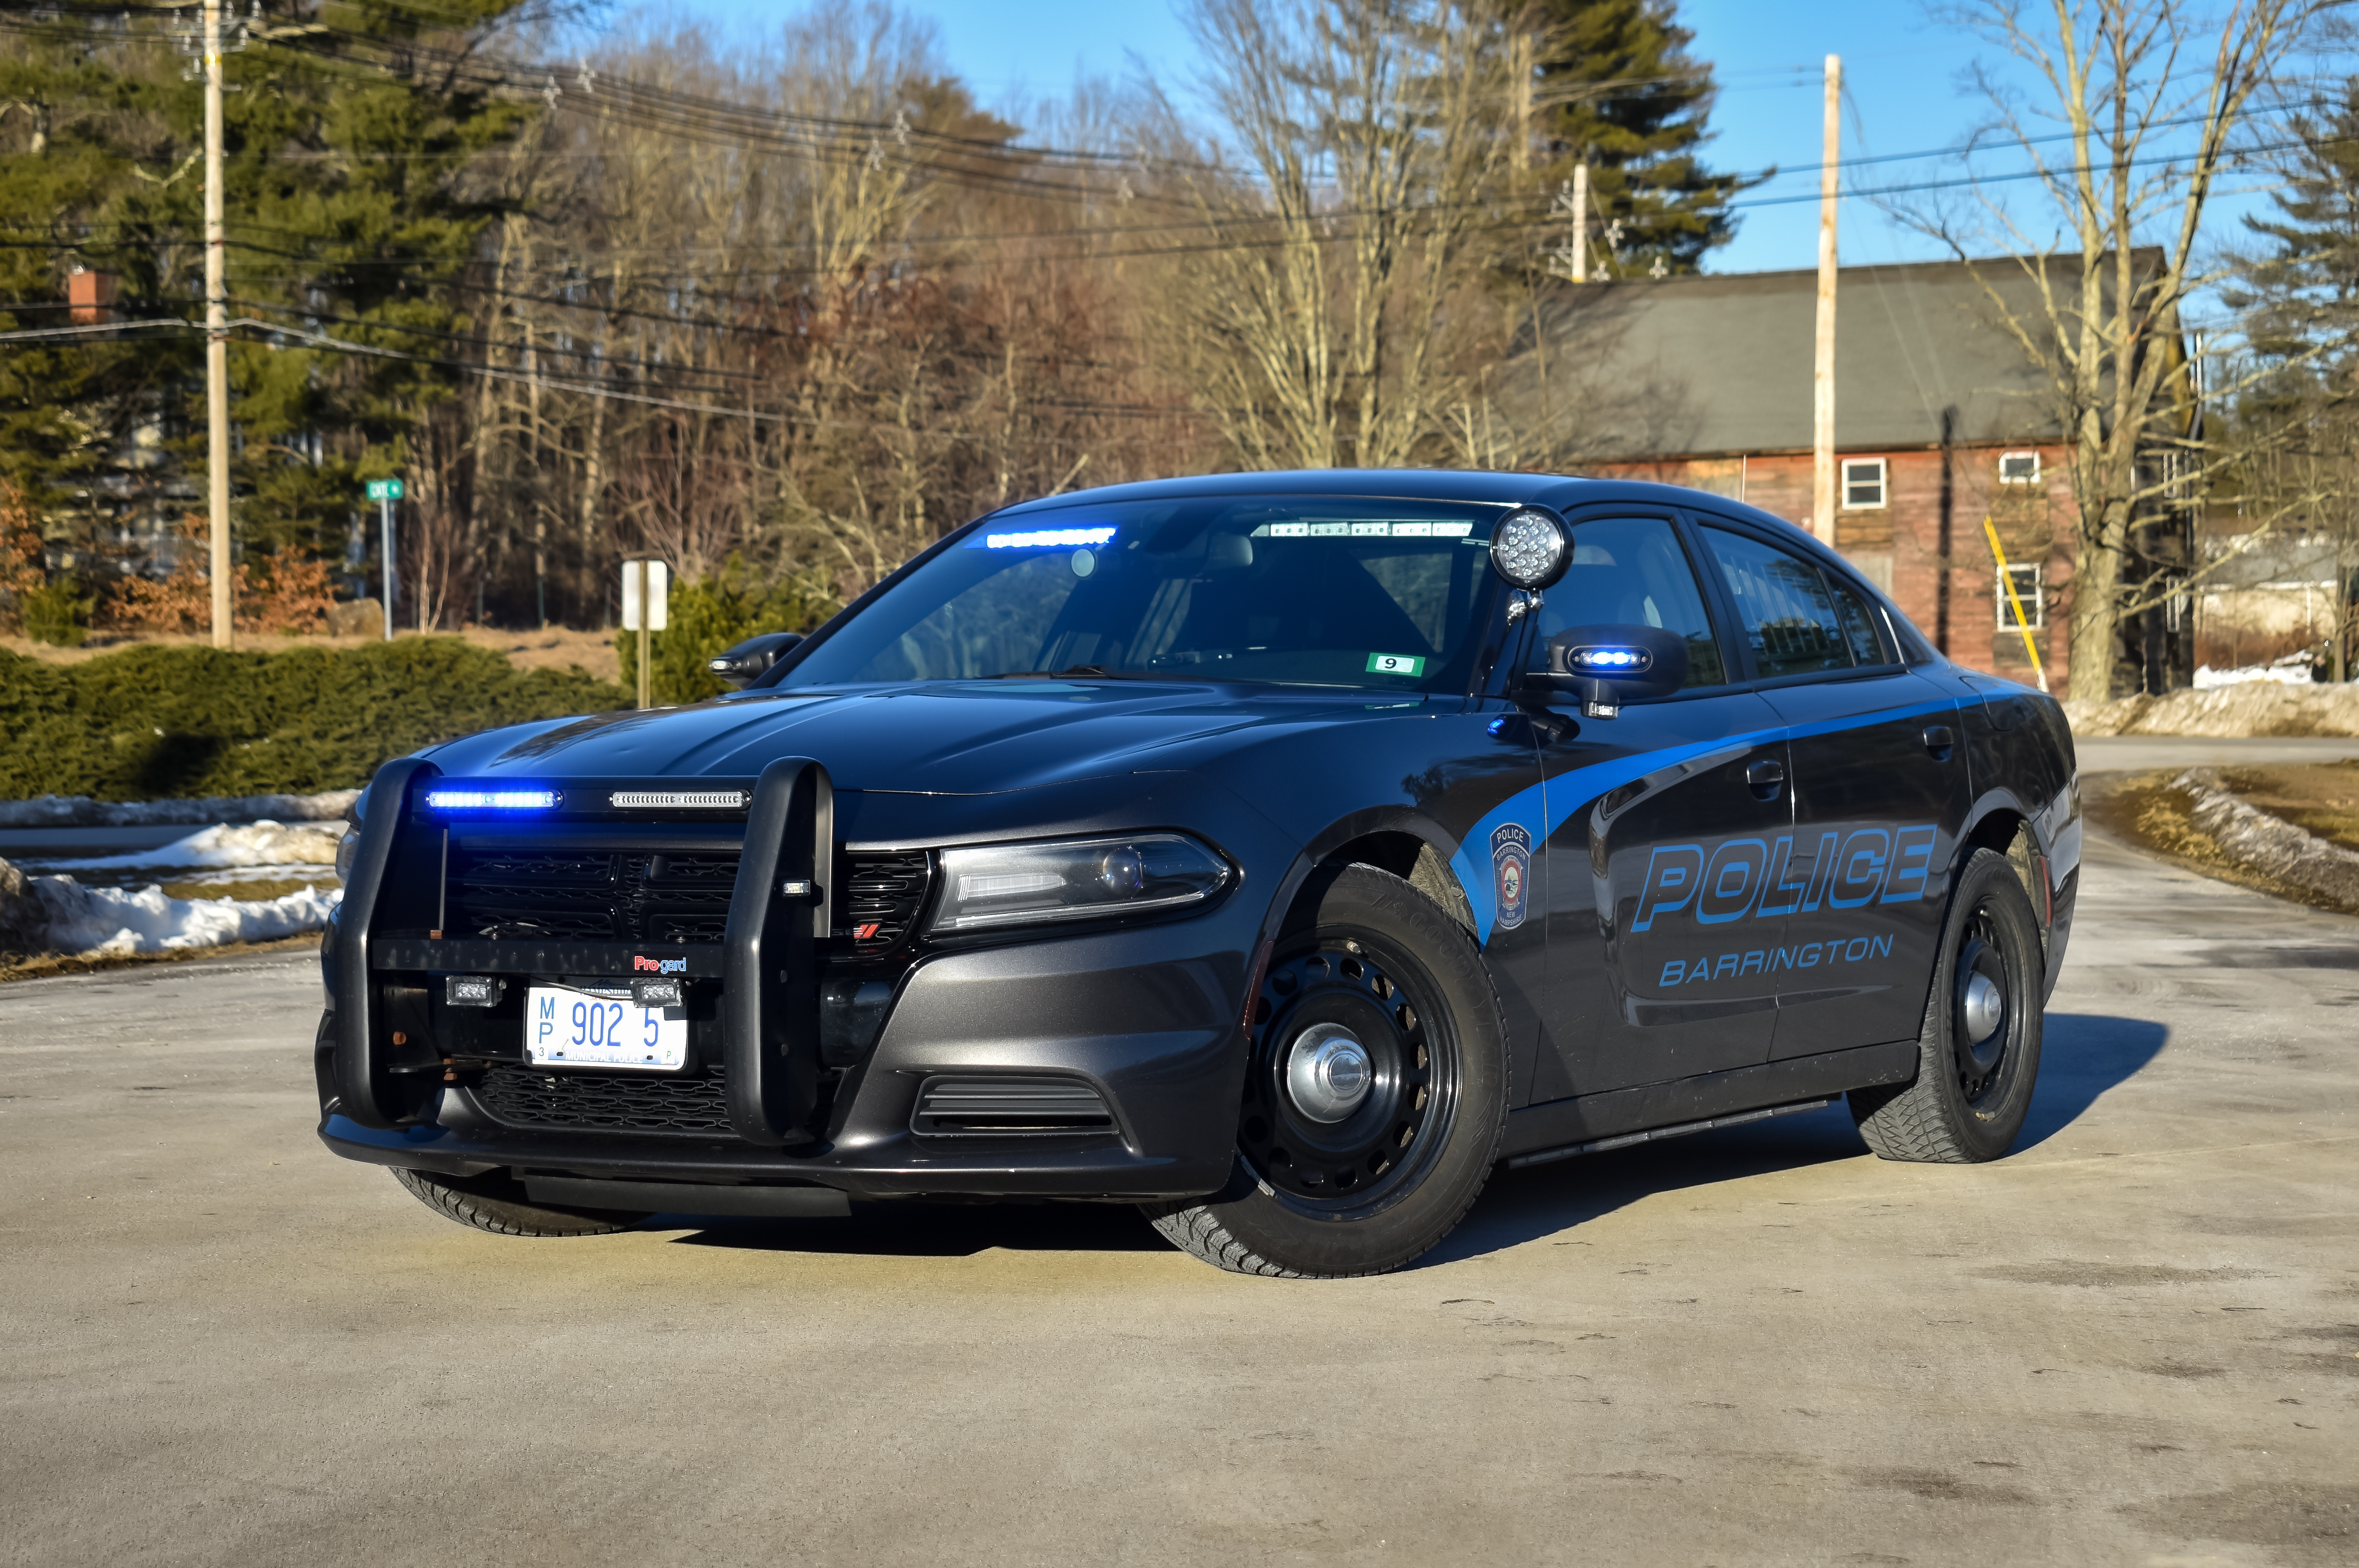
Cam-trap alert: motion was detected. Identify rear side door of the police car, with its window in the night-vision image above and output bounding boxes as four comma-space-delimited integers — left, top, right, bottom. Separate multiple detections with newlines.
1698, 521, 1970, 1059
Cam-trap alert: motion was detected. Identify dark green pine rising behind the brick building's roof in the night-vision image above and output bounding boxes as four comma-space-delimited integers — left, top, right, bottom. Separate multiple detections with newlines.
1526, 0, 1755, 276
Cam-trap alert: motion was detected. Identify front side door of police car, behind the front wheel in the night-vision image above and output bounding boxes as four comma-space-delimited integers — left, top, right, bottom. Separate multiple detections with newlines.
1522, 507, 1793, 1101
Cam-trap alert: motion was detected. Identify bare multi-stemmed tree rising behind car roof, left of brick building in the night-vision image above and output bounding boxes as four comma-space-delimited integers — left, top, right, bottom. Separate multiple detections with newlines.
1165, 0, 1512, 467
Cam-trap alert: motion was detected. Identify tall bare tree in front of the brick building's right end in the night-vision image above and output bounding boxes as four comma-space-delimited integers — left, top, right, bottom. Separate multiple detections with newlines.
1916, 0, 2328, 700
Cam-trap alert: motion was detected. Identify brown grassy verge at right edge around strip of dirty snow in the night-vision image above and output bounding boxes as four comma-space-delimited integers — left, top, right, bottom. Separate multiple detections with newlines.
2081, 762, 2359, 915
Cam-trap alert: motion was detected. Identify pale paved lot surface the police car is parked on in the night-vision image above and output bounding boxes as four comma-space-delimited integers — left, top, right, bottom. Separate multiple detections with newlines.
0, 825, 2359, 1568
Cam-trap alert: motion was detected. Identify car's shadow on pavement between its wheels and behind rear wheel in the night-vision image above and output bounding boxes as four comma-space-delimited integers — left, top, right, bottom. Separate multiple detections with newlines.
1415, 1011, 2170, 1266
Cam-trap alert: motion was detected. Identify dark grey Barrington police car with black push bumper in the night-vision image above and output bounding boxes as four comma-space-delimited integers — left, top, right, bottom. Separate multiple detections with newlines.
316, 472, 2081, 1276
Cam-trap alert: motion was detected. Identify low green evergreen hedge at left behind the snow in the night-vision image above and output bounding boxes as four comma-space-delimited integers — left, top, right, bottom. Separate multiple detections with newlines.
0, 637, 630, 799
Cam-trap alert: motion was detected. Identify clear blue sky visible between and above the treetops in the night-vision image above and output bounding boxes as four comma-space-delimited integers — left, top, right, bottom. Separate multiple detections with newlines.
655, 0, 2293, 271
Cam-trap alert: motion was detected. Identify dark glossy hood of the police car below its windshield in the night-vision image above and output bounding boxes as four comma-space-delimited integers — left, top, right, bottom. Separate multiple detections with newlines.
429, 681, 1377, 795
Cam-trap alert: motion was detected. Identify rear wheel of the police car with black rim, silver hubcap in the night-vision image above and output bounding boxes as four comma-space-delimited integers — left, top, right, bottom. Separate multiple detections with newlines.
1849, 849, 2048, 1165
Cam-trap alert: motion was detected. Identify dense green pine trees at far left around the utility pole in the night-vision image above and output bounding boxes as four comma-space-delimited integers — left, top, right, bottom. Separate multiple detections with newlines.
0, 0, 536, 568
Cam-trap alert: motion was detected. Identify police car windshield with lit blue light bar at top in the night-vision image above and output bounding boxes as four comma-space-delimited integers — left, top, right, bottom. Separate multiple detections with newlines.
778, 495, 1507, 693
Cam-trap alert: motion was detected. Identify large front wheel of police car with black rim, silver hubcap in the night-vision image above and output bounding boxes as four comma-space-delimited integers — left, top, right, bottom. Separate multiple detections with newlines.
1142, 865, 1510, 1278
